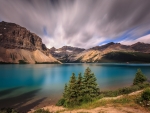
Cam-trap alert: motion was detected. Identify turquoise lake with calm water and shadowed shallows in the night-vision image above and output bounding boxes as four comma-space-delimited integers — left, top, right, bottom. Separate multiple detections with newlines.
0, 63, 150, 110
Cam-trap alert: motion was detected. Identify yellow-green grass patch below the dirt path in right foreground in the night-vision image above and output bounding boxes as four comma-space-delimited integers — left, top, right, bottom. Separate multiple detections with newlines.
62, 86, 150, 111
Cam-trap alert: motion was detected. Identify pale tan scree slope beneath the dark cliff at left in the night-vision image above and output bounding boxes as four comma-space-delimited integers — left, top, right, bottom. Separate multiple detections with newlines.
0, 47, 59, 63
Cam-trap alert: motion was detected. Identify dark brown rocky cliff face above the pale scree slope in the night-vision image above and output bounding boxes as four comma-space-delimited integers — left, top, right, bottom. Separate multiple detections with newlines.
0, 22, 48, 55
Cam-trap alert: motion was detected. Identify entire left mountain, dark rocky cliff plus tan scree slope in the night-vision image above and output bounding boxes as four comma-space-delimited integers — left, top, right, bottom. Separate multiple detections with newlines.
0, 21, 60, 63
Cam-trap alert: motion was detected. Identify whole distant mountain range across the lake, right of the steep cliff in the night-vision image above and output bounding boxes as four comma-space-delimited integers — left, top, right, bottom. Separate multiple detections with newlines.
50, 42, 150, 63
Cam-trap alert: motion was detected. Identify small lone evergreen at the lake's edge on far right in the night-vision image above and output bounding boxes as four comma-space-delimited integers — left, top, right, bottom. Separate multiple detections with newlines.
133, 69, 147, 85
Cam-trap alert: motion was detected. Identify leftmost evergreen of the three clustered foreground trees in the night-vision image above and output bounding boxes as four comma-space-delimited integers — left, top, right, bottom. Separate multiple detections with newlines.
66, 73, 77, 106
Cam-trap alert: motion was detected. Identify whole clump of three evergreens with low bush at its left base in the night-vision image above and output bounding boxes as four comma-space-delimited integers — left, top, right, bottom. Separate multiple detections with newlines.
56, 68, 100, 107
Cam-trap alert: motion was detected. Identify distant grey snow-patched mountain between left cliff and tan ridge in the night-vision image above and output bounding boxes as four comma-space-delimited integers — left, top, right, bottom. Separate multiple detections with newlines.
49, 46, 85, 63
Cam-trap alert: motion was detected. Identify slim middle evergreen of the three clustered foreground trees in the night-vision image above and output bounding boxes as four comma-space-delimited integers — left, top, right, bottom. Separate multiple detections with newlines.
76, 73, 84, 104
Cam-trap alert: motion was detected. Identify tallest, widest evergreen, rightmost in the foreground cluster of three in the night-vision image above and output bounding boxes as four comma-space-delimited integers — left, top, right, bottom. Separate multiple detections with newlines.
83, 67, 100, 101
